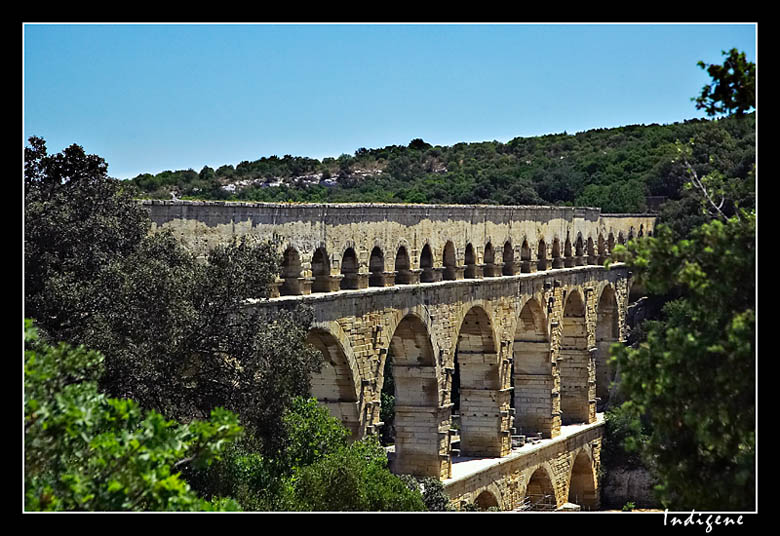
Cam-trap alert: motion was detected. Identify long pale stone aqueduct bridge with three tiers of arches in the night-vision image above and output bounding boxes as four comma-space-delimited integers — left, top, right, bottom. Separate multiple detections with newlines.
144, 201, 655, 509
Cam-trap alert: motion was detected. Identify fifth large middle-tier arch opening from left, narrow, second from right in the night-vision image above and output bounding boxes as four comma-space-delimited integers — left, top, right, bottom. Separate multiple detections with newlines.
557, 289, 595, 424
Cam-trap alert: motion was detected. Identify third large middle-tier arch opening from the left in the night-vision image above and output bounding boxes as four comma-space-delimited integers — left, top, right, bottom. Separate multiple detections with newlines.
453, 305, 510, 456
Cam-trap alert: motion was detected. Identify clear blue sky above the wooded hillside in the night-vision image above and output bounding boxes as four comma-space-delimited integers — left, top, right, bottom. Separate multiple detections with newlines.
23, 24, 757, 178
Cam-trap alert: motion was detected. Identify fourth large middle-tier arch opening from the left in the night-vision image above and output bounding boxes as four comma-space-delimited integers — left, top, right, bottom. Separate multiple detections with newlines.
512, 298, 555, 438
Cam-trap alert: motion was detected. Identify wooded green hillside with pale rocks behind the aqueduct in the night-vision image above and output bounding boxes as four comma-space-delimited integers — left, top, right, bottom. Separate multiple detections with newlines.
132, 113, 755, 213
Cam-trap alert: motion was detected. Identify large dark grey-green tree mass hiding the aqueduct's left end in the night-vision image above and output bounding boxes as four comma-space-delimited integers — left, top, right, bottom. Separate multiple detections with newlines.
25, 138, 321, 449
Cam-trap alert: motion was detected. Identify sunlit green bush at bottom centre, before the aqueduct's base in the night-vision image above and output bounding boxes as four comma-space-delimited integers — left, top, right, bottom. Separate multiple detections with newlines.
190, 398, 436, 511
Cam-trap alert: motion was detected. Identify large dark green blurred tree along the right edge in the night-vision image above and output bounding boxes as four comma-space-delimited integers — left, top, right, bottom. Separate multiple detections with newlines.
614, 210, 756, 510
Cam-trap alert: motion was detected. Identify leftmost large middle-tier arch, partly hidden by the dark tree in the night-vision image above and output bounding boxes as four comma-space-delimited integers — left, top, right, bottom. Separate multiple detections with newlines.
306, 323, 361, 439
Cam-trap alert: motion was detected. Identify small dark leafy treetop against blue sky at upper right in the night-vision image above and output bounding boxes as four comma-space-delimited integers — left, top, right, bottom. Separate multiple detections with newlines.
691, 48, 756, 116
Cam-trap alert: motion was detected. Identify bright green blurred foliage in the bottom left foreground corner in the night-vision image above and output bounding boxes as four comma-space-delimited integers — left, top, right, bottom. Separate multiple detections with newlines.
24, 320, 242, 511
